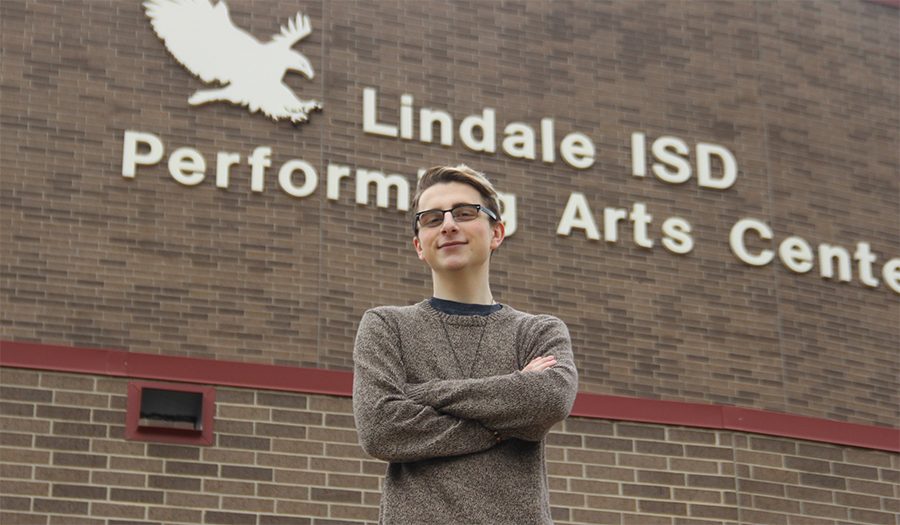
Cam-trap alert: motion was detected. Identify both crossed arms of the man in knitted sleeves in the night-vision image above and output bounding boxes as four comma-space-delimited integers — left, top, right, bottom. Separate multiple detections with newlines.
353, 311, 578, 462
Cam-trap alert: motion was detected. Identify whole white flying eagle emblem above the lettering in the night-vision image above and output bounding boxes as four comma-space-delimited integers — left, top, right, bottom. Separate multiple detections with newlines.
144, 0, 322, 124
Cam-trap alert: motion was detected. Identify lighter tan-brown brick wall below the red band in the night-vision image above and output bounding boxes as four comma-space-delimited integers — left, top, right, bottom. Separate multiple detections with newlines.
0, 368, 900, 525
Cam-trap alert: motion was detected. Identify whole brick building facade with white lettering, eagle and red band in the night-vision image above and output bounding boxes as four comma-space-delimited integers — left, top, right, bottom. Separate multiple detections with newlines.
0, 0, 900, 525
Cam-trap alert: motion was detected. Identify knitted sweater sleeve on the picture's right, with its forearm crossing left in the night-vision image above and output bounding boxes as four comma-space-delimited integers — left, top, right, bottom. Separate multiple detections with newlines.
406, 316, 578, 441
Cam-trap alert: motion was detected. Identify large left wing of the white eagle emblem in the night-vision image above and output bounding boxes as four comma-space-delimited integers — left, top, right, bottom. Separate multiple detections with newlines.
144, 0, 262, 83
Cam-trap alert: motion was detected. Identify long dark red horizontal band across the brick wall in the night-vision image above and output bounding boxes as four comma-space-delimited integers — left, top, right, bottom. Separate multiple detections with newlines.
0, 341, 900, 452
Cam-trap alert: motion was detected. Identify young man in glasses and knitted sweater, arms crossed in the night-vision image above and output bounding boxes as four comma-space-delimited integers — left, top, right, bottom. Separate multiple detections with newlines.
353, 166, 578, 525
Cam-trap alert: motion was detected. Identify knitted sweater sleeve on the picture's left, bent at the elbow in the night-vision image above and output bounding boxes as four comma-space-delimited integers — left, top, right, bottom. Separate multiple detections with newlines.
353, 310, 497, 462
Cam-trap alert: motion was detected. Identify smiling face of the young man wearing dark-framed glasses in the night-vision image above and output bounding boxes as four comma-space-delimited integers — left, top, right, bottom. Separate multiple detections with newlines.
413, 182, 505, 272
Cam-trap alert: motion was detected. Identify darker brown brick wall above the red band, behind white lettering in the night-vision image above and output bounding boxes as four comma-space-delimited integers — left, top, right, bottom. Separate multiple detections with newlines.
0, 0, 900, 425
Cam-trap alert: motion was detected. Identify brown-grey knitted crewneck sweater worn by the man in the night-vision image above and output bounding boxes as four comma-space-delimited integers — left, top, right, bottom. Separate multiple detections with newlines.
353, 301, 578, 525
